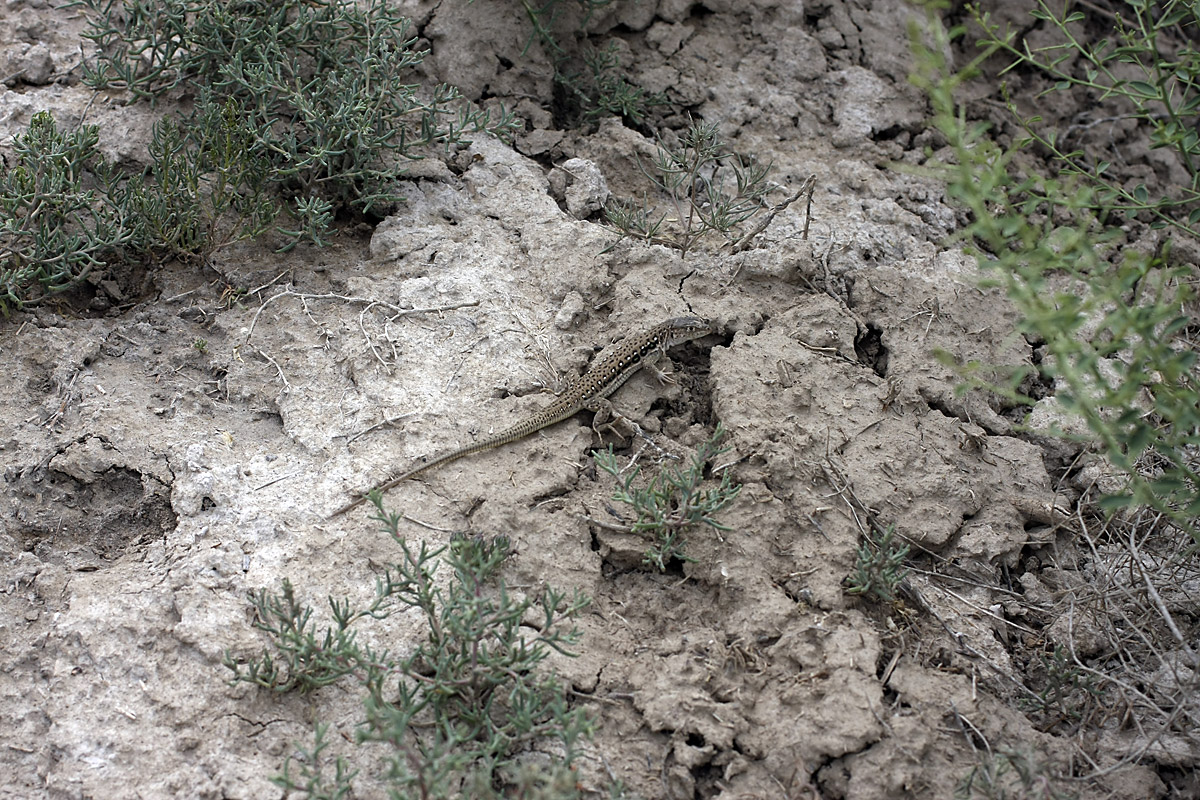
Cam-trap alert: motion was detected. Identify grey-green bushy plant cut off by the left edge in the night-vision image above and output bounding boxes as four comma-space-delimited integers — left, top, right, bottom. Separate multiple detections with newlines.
0, 112, 142, 314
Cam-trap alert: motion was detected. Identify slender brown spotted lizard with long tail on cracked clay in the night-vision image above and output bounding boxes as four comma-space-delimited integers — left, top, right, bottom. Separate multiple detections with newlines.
329, 317, 713, 519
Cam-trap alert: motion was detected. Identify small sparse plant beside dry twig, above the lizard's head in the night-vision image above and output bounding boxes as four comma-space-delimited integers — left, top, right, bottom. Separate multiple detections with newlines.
606, 121, 772, 255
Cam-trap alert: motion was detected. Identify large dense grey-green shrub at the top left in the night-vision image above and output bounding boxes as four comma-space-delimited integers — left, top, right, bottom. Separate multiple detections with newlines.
76, 0, 515, 252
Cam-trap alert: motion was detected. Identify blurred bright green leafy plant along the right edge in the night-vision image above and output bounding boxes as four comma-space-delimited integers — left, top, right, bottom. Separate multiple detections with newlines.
913, 2, 1200, 542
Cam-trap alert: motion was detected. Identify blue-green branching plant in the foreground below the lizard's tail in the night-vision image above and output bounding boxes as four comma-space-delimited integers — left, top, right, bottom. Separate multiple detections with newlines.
226, 493, 590, 798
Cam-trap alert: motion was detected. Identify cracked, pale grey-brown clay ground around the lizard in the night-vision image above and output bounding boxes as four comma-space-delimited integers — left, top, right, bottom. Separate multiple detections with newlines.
0, 0, 1198, 800
